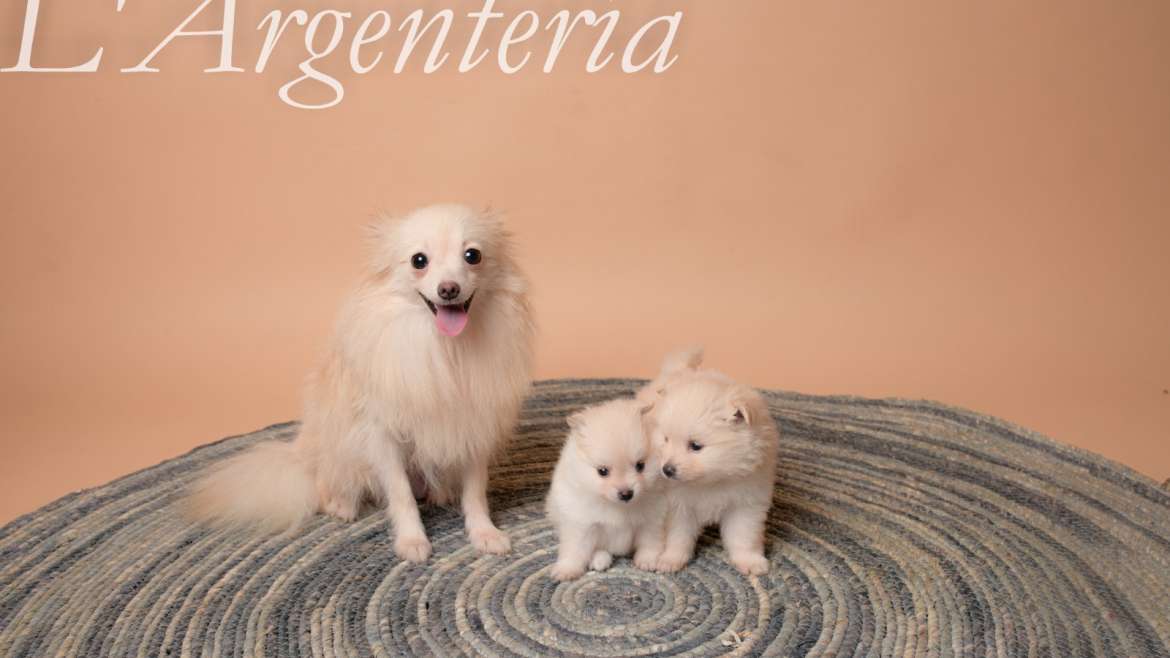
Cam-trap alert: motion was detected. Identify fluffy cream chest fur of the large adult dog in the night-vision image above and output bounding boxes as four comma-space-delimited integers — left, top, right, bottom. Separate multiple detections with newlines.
334, 284, 531, 475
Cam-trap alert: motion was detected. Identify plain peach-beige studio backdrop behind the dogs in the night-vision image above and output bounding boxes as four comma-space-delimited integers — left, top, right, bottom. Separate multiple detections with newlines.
0, 0, 1170, 521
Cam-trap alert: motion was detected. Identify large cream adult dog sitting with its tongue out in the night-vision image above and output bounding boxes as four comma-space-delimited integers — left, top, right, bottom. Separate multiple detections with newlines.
191, 205, 534, 562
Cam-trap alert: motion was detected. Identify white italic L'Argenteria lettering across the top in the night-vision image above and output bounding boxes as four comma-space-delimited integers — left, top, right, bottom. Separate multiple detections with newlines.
0, 0, 683, 110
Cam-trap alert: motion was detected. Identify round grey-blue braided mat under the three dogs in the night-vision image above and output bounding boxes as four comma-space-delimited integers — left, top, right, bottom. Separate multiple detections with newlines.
0, 381, 1170, 658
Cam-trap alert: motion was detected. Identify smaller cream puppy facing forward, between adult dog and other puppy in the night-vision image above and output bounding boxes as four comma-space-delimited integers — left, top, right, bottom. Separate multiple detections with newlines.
546, 399, 666, 581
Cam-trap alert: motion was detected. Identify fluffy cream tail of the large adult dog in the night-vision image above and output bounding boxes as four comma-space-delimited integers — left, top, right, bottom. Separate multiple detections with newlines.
187, 441, 318, 532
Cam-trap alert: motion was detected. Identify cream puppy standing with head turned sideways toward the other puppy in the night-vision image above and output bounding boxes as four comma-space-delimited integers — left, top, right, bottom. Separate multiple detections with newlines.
638, 348, 779, 575
